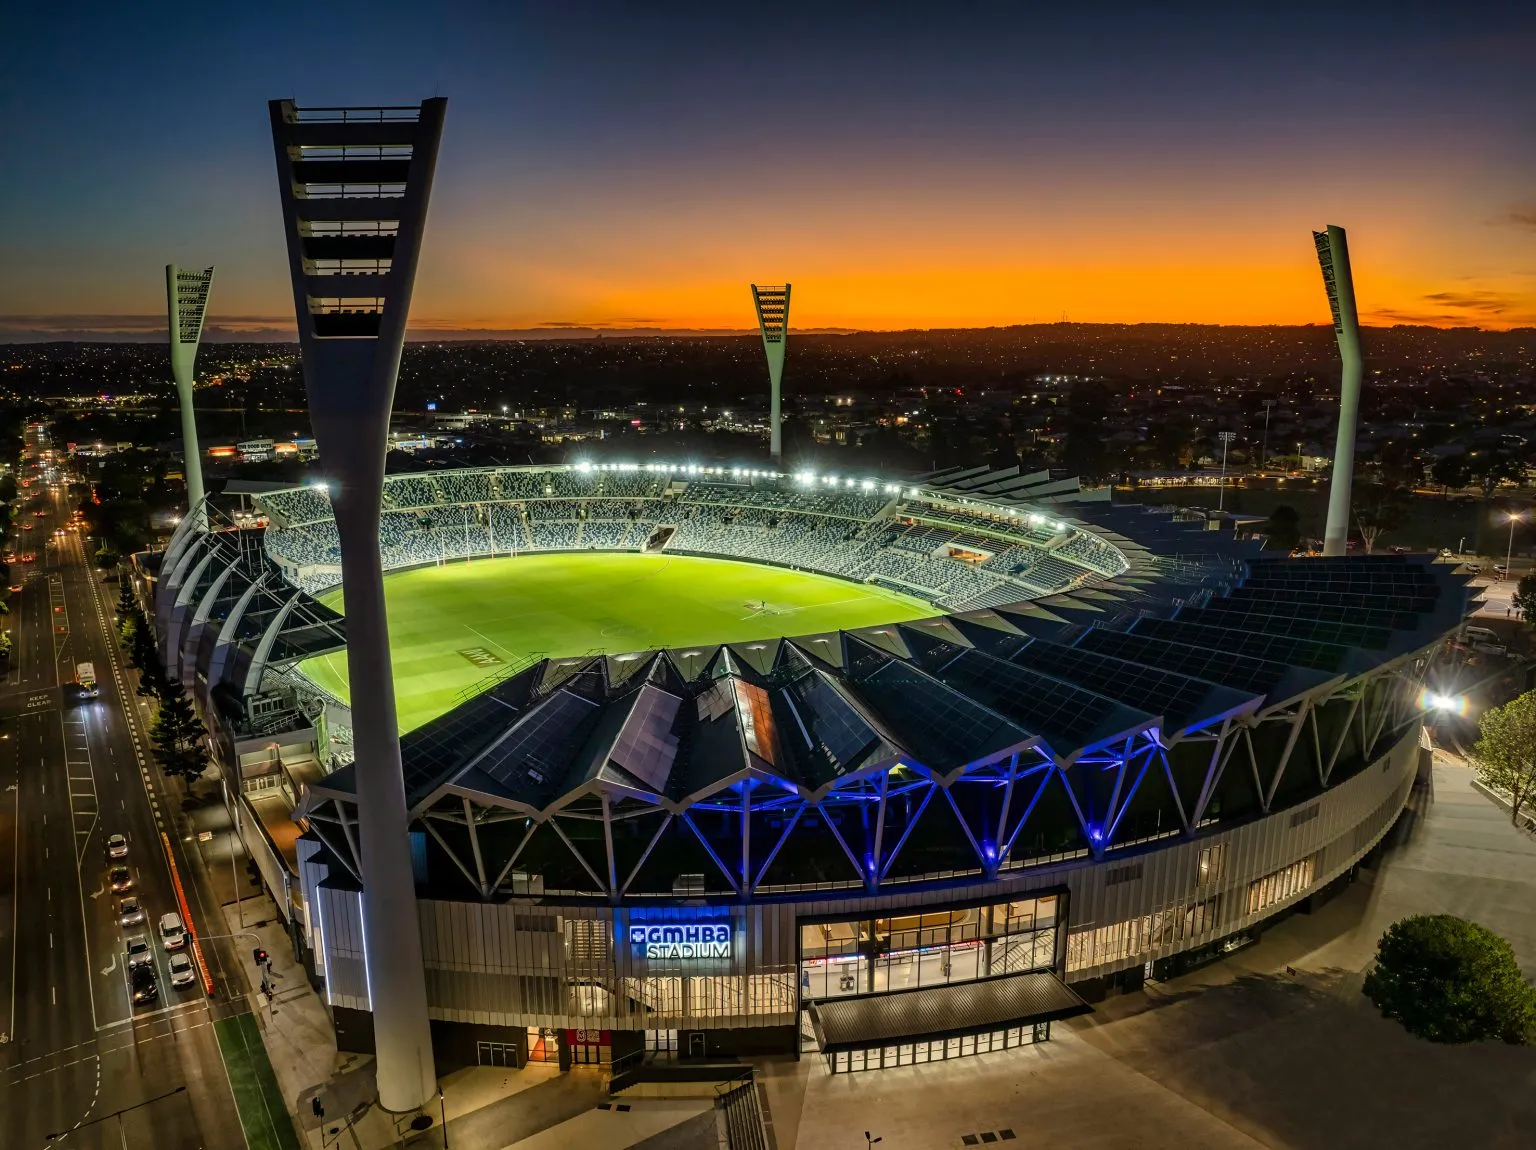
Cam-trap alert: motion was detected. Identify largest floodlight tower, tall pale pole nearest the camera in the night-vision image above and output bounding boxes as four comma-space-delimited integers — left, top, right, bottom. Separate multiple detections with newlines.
269, 98, 447, 1112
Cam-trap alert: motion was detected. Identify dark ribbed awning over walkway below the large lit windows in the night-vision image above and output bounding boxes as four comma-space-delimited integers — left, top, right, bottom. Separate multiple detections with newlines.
811, 970, 1094, 1055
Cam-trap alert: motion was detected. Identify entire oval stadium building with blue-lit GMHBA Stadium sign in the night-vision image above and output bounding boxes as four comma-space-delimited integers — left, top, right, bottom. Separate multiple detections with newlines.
144, 465, 1468, 1073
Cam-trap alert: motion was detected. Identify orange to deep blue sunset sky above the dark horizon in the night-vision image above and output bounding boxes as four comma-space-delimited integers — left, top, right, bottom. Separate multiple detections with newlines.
0, 0, 1536, 339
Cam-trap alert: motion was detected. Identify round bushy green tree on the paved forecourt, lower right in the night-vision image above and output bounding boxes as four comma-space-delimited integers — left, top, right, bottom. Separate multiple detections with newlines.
1364, 915, 1536, 1046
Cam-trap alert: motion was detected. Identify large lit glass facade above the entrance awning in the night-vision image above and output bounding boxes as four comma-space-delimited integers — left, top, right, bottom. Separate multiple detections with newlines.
800, 895, 1057, 1001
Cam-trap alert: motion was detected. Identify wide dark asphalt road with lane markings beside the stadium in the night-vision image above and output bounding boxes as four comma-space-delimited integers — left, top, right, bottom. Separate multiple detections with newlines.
0, 428, 246, 1150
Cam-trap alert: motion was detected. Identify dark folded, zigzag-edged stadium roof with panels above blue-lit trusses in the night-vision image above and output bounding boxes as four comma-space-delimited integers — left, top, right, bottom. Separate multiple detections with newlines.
321, 556, 1467, 817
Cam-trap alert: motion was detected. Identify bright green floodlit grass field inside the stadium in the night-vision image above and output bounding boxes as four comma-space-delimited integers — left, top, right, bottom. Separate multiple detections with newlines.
300, 553, 934, 731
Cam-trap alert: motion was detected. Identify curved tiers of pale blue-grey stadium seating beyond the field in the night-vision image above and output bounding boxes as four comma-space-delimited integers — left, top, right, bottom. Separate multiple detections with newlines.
248, 467, 1126, 610
